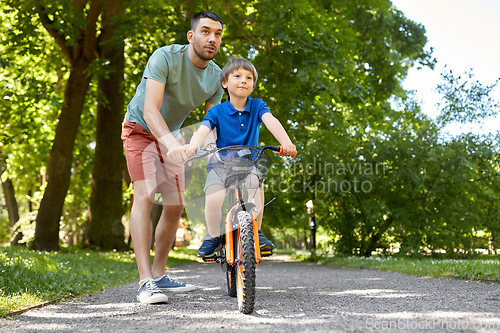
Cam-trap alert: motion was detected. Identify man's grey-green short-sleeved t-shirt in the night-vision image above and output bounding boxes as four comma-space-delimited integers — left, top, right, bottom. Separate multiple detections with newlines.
125, 44, 223, 133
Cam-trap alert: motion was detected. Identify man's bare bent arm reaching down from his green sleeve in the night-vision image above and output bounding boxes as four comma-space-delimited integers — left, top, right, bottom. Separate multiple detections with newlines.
144, 79, 187, 163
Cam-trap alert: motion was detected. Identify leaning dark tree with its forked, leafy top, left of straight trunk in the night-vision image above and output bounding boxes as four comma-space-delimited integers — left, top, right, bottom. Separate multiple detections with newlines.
30, 0, 103, 250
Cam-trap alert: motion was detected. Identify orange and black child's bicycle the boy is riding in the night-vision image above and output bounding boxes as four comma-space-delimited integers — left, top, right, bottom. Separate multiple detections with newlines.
185, 146, 292, 314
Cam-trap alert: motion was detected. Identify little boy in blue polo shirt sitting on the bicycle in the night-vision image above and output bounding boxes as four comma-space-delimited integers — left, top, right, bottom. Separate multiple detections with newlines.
186, 58, 296, 258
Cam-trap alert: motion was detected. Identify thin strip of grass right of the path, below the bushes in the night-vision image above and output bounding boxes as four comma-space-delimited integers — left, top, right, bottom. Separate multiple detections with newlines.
295, 250, 500, 282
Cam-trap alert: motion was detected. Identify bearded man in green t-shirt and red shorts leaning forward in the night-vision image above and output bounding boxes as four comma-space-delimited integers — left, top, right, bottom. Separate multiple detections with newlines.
122, 11, 223, 303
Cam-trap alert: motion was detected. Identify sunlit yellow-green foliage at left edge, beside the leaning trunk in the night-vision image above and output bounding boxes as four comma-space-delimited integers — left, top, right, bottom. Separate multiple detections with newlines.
0, 4, 64, 245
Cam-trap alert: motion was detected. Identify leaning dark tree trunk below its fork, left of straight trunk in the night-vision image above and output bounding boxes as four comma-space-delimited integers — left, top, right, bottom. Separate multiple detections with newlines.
34, 59, 91, 251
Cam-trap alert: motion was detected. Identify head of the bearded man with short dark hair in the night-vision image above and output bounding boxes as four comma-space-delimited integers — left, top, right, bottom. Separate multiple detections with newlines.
188, 17, 222, 61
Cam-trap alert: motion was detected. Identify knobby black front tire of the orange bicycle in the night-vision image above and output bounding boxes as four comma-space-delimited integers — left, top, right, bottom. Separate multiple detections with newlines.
236, 211, 256, 314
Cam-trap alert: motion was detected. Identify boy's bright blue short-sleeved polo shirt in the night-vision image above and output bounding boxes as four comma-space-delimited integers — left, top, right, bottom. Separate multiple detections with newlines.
201, 97, 271, 148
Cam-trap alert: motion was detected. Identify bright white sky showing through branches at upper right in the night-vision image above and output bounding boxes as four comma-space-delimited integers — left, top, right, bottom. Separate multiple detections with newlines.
392, 0, 500, 134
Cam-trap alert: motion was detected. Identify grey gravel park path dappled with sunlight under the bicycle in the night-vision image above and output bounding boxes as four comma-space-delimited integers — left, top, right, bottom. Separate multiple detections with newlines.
0, 256, 500, 333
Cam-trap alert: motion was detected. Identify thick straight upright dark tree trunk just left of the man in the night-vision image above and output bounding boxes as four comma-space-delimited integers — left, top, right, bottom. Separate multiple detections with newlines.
86, 0, 126, 249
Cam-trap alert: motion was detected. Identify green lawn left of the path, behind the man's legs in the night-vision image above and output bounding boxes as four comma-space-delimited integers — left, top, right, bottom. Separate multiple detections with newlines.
0, 247, 197, 317
